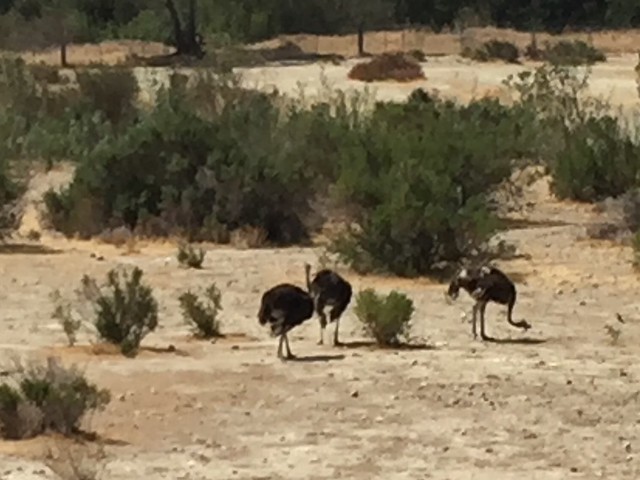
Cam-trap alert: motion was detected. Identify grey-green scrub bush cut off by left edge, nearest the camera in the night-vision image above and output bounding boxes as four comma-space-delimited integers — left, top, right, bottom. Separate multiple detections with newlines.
0, 358, 111, 440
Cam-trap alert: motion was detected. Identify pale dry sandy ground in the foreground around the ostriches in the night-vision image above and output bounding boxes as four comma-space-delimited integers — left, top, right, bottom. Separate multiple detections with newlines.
0, 31, 640, 480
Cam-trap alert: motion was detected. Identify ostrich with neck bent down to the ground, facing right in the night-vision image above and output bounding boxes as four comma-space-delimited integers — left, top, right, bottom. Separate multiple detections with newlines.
447, 266, 531, 340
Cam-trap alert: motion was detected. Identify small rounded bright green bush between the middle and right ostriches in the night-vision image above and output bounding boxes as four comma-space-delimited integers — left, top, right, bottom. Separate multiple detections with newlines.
354, 288, 414, 347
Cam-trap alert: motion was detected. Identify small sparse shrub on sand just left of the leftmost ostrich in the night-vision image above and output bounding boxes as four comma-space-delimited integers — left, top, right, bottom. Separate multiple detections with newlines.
178, 283, 222, 339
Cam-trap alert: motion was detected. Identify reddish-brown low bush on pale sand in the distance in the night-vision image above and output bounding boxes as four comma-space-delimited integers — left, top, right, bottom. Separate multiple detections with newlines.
348, 53, 424, 82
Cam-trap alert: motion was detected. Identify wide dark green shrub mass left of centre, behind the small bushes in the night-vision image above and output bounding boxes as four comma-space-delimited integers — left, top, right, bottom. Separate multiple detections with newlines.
45, 78, 313, 248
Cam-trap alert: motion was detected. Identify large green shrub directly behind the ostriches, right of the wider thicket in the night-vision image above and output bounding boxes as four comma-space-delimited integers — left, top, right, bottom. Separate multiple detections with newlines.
331, 96, 519, 276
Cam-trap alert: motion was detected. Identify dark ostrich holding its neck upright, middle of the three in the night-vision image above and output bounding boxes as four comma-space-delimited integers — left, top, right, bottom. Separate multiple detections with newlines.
304, 263, 352, 345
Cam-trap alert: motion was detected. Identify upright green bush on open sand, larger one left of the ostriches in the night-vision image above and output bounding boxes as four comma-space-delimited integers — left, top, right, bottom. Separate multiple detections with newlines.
82, 267, 158, 356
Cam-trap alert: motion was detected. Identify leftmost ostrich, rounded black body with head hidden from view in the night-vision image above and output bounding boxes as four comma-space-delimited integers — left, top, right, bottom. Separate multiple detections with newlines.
258, 283, 313, 360
